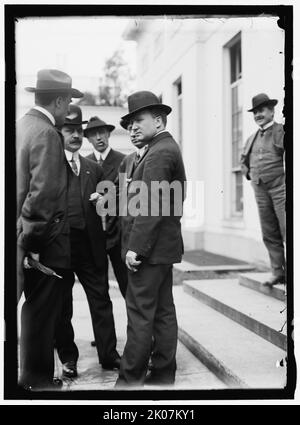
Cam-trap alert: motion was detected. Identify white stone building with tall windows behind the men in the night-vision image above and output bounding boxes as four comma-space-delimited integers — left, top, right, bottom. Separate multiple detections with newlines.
123, 17, 284, 264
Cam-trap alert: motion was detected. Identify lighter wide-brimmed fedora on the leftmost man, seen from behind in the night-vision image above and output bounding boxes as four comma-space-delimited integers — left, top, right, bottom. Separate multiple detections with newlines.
25, 69, 83, 97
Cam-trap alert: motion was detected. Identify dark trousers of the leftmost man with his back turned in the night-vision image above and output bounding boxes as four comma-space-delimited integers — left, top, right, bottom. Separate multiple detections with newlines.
20, 269, 64, 387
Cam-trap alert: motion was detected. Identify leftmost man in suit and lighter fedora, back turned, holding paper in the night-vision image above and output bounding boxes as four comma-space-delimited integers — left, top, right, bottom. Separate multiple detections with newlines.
16, 69, 83, 390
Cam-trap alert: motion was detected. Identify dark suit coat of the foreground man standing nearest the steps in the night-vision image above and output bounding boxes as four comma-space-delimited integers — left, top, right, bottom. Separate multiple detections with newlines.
120, 131, 186, 264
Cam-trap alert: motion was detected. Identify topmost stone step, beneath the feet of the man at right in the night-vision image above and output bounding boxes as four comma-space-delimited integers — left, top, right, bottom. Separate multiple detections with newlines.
239, 273, 286, 301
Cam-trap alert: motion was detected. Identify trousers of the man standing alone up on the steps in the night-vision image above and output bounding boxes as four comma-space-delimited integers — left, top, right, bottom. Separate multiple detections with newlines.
252, 176, 286, 276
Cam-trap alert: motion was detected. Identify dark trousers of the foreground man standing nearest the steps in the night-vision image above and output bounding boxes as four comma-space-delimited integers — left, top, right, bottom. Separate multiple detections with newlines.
116, 262, 178, 386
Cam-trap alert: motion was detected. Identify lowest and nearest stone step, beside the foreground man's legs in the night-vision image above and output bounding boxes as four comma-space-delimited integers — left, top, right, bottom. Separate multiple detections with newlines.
173, 286, 286, 389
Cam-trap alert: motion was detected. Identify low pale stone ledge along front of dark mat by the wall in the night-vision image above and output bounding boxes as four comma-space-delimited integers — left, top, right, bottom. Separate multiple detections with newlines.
173, 261, 254, 285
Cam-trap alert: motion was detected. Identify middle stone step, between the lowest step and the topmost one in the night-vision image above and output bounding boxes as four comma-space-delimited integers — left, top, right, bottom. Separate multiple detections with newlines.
183, 279, 287, 350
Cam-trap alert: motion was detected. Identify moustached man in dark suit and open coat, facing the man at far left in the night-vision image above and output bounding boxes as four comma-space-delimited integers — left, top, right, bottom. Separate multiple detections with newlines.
56, 105, 120, 377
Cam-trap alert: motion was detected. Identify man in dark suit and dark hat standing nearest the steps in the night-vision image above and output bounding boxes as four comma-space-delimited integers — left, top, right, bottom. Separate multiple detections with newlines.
116, 91, 186, 387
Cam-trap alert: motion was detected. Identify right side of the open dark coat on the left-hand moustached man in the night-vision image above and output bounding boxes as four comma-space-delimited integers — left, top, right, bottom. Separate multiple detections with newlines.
79, 155, 106, 267
